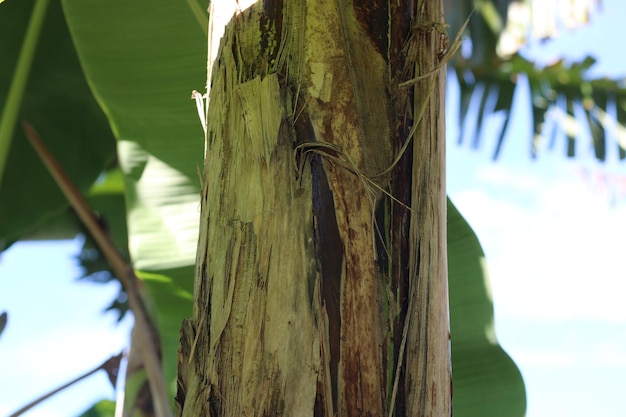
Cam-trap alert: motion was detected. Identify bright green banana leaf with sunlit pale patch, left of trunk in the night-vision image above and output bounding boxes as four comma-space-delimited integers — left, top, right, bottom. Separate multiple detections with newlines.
63, 0, 206, 398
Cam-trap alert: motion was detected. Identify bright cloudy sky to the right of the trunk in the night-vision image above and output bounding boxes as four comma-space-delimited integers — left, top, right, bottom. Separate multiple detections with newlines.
448, 0, 626, 417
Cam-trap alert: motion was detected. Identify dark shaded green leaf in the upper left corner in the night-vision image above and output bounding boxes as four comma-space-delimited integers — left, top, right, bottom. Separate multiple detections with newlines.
0, 0, 115, 250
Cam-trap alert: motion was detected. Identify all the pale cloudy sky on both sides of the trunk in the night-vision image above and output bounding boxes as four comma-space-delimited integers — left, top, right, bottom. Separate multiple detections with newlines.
0, 0, 626, 417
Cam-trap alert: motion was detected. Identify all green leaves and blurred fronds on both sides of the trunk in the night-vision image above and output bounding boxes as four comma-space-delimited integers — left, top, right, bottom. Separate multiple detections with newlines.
0, 0, 626, 417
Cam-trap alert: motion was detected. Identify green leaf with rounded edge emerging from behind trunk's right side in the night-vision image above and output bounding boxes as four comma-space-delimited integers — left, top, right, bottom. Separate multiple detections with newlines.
448, 199, 526, 417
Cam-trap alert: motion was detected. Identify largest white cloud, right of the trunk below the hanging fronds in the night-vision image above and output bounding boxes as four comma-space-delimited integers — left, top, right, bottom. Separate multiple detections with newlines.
453, 158, 626, 322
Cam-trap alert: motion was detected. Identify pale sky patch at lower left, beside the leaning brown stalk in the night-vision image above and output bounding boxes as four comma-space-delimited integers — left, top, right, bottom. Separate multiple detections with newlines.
0, 239, 131, 417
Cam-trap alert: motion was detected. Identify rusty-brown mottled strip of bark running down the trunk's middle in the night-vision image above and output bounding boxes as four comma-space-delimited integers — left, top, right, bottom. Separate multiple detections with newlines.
302, 0, 392, 416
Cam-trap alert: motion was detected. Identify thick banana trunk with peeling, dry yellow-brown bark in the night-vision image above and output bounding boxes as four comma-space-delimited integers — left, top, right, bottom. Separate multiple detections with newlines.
176, 0, 452, 417
